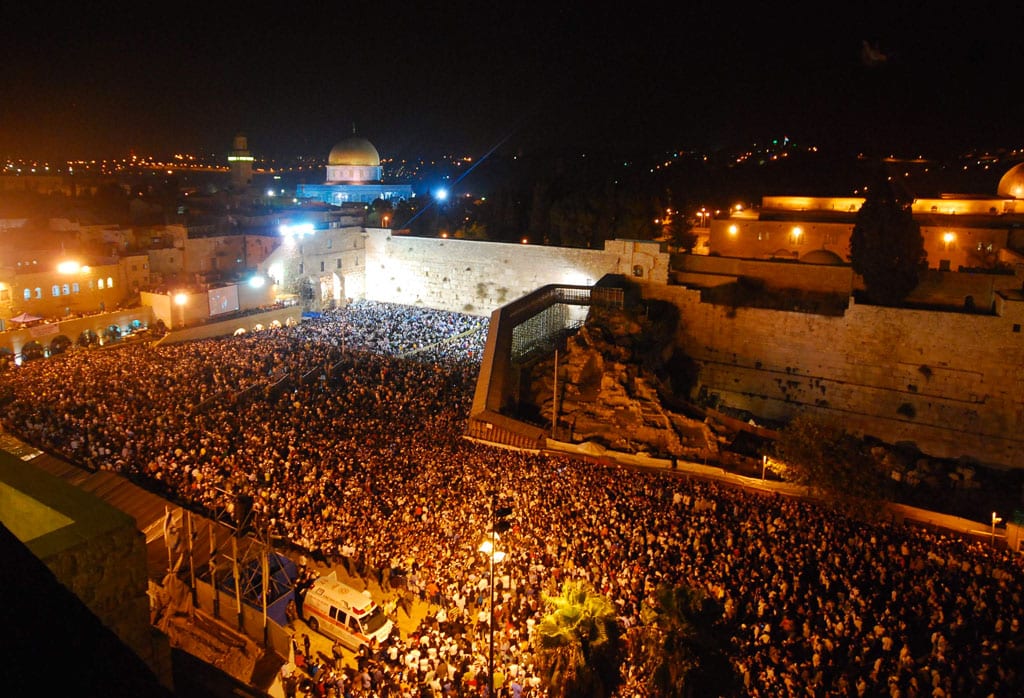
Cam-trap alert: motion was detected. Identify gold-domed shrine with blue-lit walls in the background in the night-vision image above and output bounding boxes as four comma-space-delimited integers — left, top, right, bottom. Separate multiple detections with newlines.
295, 133, 413, 205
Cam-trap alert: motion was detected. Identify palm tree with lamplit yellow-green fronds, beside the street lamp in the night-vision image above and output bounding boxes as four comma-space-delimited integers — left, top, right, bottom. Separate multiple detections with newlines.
534, 580, 620, 698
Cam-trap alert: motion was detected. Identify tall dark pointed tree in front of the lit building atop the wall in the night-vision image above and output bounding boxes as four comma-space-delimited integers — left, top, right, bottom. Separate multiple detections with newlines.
850, 166, 927, 305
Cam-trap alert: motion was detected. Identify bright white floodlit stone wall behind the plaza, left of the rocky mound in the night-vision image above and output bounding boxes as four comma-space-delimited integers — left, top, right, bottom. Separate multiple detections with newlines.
366, 228, 669, 315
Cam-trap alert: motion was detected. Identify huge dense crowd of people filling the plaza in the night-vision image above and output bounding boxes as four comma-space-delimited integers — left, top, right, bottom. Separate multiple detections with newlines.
2, 301, 1024, 698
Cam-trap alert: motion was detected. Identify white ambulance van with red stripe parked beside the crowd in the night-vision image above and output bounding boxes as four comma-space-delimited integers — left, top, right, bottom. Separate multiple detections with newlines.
302, 572, 393, 650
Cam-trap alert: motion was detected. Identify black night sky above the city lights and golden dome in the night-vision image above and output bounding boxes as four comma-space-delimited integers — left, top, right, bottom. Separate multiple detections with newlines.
0, 0, 1024, 160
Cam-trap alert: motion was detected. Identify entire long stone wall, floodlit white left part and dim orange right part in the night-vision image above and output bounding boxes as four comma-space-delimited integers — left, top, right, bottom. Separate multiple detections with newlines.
358, 231, 1024, 468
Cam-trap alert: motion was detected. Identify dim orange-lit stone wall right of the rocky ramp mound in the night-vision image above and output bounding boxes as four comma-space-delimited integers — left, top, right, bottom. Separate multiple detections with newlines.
644, 285, 1024, 467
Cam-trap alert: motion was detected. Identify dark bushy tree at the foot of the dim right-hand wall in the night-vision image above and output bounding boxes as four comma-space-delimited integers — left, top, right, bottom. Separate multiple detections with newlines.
772, 413, 888, 514
